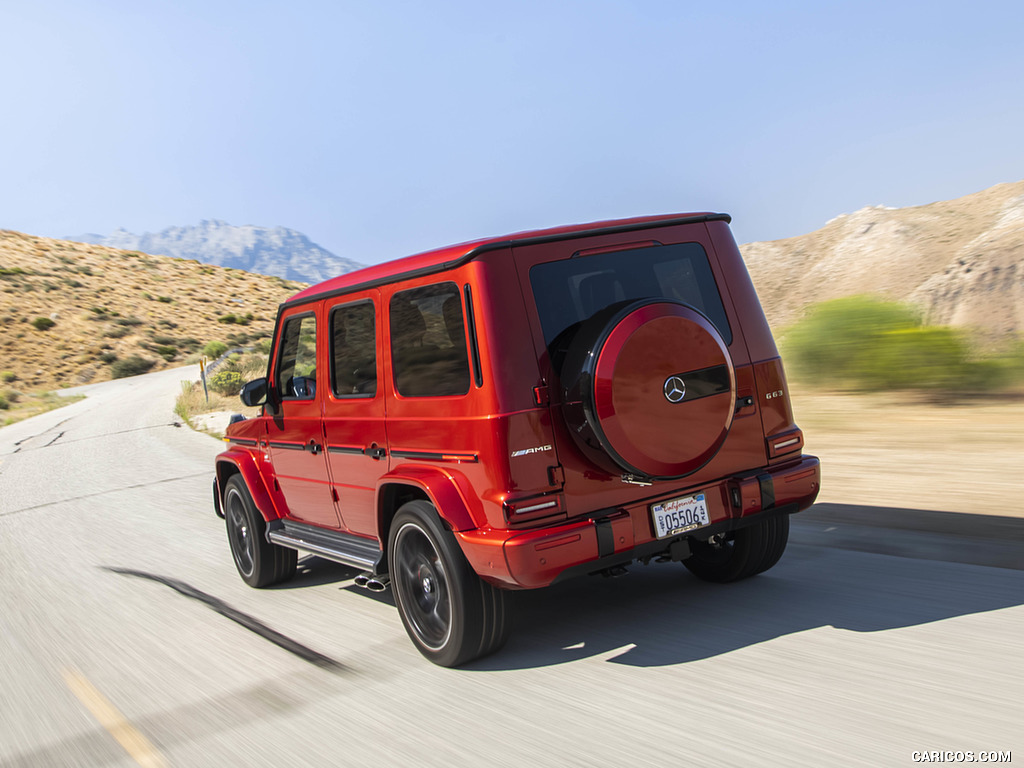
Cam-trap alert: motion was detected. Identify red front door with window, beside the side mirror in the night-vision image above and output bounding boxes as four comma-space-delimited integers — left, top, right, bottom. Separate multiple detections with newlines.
267, 306, 341, 528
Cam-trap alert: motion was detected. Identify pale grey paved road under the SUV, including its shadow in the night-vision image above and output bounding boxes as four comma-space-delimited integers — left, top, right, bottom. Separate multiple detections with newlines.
0, 369, 1024, 768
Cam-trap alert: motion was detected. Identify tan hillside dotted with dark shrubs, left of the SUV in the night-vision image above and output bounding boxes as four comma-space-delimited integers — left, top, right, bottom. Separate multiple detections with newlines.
0, 230, 302, 390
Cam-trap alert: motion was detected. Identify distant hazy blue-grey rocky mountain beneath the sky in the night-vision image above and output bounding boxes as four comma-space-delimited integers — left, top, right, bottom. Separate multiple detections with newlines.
69, 219, 365, 283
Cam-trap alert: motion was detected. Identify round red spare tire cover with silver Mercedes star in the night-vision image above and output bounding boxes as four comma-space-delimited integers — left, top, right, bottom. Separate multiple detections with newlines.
561, 299, 736, 479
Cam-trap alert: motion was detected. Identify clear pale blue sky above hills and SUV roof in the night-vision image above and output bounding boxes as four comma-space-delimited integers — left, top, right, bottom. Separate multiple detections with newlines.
0, 0, 1024, 263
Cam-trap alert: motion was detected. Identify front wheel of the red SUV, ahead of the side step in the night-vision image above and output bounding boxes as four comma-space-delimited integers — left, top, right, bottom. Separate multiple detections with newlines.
223, 475, 298, 587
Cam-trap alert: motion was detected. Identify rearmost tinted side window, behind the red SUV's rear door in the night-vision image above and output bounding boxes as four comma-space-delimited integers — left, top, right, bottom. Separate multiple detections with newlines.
390, 283, 469, 397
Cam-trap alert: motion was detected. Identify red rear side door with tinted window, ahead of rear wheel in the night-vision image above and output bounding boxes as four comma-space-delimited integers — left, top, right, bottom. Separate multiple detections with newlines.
324, 290, 388, 537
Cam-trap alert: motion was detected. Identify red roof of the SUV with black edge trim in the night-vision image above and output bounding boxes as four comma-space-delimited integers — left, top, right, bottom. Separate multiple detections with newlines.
283, 212, 731, 306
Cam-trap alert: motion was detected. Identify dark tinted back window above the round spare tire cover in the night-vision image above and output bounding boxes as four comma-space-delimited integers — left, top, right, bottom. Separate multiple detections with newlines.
529, 243, 732, 371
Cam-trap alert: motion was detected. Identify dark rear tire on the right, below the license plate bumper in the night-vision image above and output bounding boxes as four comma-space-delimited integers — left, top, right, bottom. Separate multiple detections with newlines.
683, 514, 790, 583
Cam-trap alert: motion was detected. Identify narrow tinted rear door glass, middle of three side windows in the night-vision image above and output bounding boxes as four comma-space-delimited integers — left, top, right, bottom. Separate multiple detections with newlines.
331, 301, 377, 397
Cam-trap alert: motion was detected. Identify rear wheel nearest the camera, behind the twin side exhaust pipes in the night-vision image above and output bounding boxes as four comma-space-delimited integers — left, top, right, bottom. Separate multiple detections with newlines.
388, 500, 510, 667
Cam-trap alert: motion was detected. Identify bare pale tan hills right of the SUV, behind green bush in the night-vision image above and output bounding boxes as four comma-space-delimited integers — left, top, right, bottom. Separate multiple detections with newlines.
740, 181, 1024, 337
